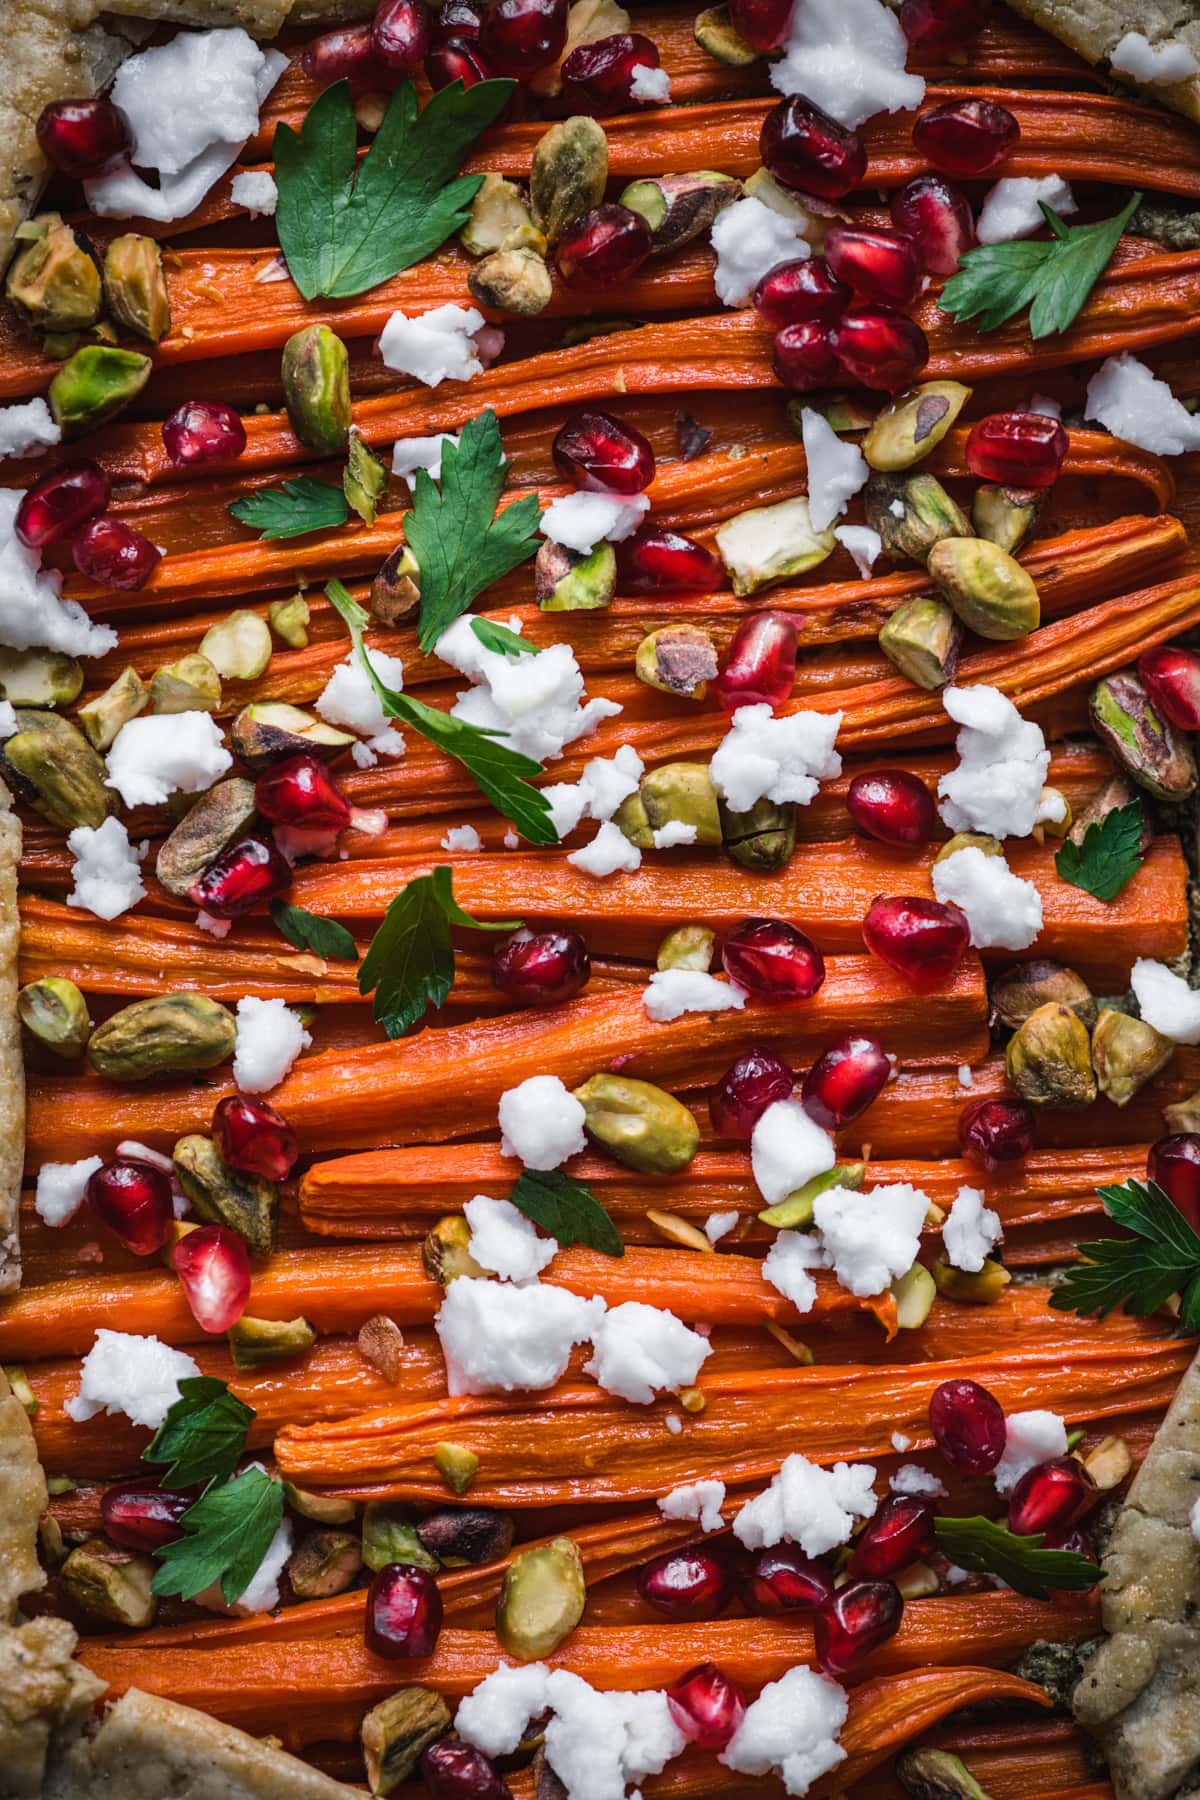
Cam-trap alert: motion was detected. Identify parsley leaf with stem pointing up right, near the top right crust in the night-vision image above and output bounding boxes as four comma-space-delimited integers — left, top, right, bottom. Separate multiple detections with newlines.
937, 194, 1142, 338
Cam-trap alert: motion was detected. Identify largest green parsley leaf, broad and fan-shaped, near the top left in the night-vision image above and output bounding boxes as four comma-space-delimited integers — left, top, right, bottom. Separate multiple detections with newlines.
273, 81, 515, 301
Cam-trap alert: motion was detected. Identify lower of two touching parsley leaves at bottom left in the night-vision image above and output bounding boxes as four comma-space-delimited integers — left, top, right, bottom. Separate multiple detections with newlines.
151, 1469, 282, 1606
